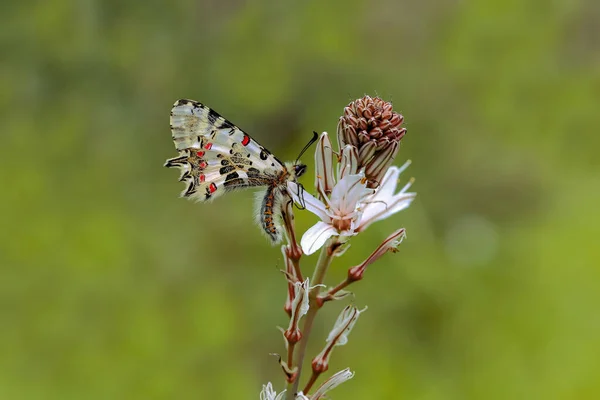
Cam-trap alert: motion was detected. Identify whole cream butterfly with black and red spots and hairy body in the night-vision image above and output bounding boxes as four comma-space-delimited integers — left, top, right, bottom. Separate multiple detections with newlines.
165, 99, 308, 244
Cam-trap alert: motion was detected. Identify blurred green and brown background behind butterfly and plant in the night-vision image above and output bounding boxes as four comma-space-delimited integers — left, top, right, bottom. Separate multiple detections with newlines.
0, 0, 600, 400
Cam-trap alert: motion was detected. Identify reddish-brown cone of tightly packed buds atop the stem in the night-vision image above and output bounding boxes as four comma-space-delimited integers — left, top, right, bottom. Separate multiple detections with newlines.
337, 96, 406, 188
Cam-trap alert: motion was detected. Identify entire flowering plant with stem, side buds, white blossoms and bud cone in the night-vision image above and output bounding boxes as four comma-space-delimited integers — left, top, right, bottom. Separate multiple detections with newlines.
260, 96, 416, 400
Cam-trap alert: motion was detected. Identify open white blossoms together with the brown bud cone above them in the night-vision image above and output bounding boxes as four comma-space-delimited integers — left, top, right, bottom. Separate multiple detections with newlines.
288, 96, 416, 254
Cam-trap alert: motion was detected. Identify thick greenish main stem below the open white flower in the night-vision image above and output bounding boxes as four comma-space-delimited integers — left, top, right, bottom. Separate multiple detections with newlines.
285, 238, 337, 400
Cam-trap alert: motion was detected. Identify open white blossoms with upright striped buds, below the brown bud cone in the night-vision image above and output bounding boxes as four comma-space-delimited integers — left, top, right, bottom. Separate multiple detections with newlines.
288, 132, 416, 254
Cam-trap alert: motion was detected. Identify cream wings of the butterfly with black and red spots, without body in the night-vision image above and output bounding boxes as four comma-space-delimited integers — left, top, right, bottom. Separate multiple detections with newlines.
165, 100, 285, 201
